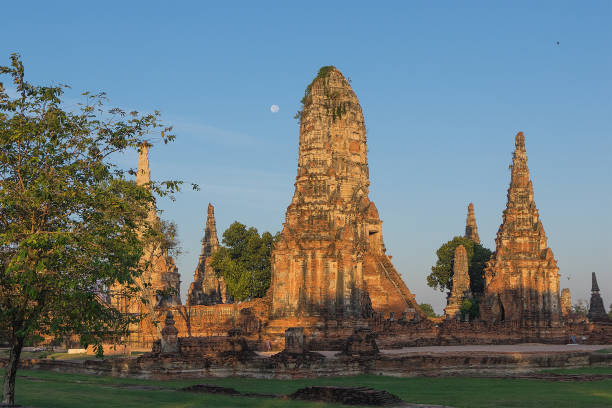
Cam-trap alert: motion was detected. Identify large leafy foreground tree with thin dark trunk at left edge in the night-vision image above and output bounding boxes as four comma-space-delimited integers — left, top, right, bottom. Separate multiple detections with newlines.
0, 54, 180, 404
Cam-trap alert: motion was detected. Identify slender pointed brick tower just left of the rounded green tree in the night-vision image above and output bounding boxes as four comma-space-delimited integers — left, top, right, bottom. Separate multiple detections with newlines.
187, 203, 229, 306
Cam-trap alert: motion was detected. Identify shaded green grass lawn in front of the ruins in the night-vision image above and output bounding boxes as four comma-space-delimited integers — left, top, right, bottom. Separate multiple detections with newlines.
3, 369, 612, 408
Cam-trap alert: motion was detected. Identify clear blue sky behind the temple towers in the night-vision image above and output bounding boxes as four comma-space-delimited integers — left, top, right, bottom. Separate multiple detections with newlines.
0, 1, 612, 312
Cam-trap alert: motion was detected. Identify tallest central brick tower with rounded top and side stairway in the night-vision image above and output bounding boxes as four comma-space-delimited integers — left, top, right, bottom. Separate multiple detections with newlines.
270, 67, 420, 318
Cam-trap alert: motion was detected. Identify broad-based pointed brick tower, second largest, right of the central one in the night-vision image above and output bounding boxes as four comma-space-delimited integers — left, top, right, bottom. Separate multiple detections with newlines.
481, 132, 560, 326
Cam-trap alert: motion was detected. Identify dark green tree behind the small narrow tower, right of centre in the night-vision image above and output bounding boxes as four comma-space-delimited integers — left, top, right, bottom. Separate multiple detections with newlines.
427, 237, 492, 294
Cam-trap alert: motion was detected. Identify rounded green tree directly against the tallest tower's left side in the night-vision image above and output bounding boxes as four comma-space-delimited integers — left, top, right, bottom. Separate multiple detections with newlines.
211, 221, 279, 300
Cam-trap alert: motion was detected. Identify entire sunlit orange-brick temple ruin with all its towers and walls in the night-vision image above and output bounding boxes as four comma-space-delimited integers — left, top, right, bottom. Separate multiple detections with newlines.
110, 67, 612, 354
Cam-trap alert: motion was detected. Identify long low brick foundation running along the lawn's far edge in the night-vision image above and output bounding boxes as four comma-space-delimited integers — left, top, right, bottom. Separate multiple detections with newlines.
5, 345, 612, 379
